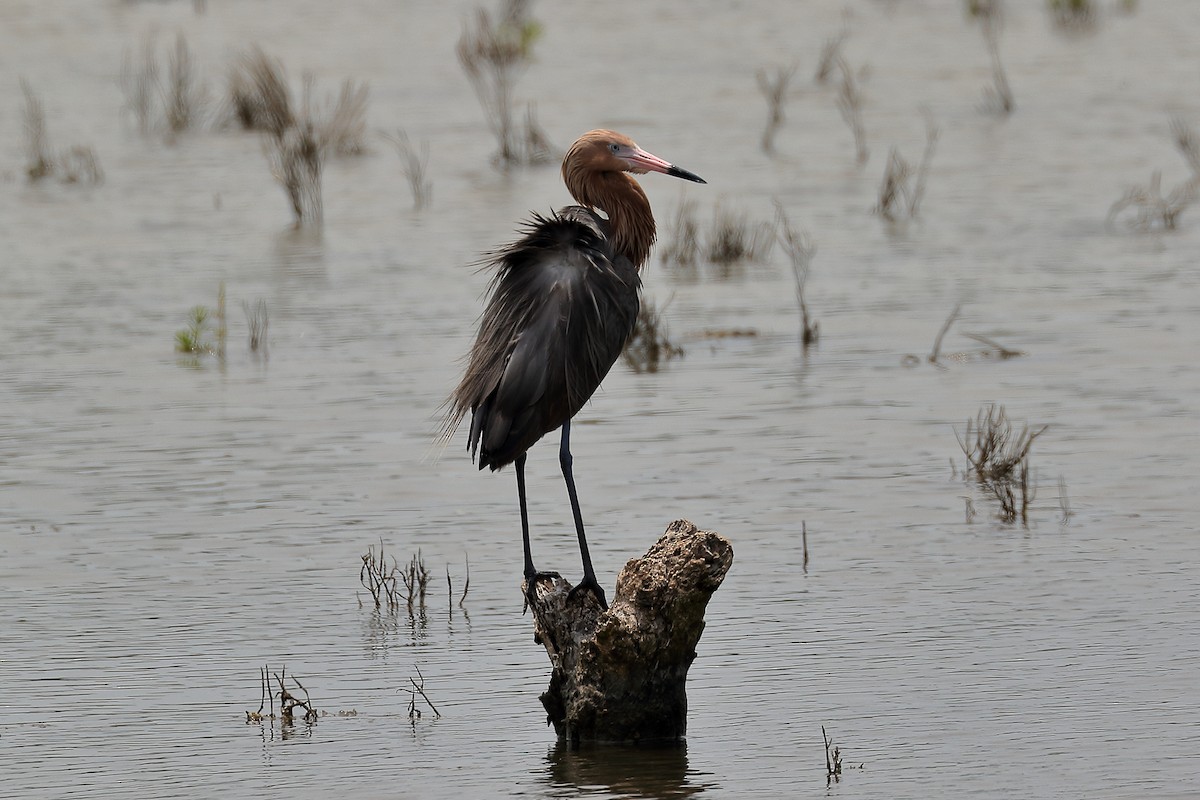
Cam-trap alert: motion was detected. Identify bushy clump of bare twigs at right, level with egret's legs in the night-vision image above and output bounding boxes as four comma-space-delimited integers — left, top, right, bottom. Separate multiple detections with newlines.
954, 404, 1049, 528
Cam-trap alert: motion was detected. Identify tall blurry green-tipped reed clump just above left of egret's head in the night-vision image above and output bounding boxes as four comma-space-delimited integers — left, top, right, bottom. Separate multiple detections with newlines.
457, 0, 557, 169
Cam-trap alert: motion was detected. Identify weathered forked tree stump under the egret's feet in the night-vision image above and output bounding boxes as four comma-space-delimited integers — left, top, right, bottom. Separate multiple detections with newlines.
530, 519, 733, 742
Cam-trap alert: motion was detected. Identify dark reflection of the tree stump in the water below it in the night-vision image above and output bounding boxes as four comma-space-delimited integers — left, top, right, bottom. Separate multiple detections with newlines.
546, 741, 713, 798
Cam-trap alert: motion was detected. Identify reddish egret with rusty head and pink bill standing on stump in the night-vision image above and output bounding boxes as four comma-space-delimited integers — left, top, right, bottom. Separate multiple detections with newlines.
445, 131, 704, 608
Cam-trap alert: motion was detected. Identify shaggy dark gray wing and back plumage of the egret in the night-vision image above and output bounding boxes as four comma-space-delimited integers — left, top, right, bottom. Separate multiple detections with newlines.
448, 206, 641, 469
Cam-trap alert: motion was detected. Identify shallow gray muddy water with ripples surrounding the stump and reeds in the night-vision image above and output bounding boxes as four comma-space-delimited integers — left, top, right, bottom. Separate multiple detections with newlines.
0, 0, 1200, 798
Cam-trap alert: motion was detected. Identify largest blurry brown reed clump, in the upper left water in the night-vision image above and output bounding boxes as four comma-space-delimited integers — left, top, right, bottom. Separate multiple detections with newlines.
229, 47, 368, 225
